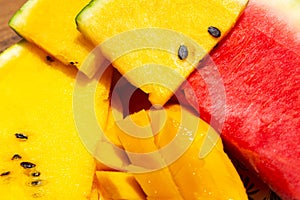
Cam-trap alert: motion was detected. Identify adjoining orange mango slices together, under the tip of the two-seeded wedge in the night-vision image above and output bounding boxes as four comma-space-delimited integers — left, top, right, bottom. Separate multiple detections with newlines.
107, 105, 247, 200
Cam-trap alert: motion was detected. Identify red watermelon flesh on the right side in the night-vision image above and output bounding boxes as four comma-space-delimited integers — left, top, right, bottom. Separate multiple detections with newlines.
179, 2, 300, 199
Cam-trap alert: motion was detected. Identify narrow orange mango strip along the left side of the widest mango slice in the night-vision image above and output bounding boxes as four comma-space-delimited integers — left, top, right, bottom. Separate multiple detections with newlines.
111, 110, 182, 199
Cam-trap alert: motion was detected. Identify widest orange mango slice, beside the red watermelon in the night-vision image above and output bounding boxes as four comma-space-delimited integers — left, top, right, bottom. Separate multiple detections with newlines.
157, 105, 247, 200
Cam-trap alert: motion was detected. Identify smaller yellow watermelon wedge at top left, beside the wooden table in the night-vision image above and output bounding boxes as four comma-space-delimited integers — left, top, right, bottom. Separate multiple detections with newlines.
9, 0, 101, 76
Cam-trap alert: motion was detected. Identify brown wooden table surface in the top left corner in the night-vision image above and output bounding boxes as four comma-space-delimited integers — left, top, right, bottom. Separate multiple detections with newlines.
0, 0, 26, 52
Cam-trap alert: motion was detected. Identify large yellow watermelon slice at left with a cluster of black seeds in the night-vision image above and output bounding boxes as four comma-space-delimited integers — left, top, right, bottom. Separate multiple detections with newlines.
0, 42, 109, 200
